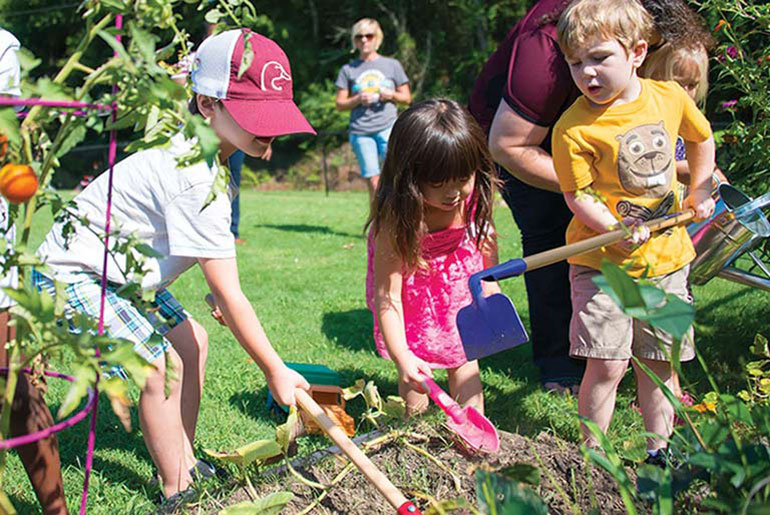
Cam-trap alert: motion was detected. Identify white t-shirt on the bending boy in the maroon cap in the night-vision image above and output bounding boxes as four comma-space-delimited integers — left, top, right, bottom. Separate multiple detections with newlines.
37, 134, 235, 289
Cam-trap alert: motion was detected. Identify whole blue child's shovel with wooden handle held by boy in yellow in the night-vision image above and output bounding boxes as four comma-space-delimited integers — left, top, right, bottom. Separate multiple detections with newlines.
457, 210, 695, 360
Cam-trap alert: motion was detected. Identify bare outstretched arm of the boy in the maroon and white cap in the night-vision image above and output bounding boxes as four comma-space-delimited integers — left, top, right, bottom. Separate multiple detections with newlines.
198, 258, 310, 405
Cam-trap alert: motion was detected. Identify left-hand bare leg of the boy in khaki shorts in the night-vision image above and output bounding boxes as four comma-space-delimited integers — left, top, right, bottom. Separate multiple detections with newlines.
578, 358, 628, 447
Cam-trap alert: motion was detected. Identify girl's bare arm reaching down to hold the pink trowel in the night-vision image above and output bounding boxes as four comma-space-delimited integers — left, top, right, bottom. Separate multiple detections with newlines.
374, 231, 433, 386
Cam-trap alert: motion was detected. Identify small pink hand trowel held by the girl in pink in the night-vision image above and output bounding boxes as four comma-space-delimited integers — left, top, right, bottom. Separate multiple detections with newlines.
422, 374, 500, 454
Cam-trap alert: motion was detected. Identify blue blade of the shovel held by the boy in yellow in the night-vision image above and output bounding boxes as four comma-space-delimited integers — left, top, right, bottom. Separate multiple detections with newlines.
457, 293, 529, 361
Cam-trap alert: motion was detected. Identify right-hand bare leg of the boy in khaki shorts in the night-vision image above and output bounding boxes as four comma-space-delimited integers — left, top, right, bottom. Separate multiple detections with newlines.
634, 359, 674, 451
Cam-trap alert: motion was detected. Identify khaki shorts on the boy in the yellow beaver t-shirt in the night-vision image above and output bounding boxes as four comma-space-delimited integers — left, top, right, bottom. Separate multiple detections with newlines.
569, 265, 695, 361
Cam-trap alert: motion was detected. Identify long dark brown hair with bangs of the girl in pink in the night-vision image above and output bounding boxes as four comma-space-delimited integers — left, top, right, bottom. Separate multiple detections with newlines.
364, 98, 497, 270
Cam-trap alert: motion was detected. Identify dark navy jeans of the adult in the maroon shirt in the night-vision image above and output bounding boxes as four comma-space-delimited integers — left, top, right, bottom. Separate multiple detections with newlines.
498, 166, 585, 383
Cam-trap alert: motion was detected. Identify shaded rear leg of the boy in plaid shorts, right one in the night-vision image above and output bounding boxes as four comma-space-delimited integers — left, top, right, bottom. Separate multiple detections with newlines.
166, 318, 209, 445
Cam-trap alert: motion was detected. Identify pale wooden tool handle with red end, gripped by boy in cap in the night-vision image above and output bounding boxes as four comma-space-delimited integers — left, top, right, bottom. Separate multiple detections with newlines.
294, 389, 422, 515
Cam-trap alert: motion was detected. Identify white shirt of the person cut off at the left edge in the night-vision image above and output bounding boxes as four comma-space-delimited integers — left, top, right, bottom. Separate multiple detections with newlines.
0, 29, 21, 309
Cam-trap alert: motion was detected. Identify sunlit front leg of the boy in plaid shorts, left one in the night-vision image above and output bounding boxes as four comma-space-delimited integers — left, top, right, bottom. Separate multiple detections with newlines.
139, 348, 195, 497
